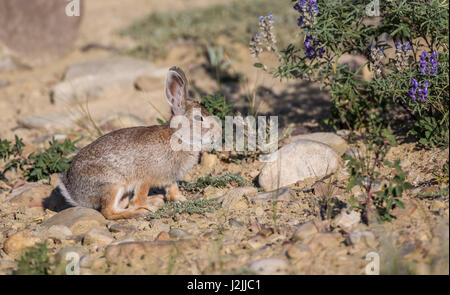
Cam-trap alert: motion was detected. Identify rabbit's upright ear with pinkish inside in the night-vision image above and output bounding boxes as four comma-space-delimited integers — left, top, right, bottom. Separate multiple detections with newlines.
166, 67, 187, 115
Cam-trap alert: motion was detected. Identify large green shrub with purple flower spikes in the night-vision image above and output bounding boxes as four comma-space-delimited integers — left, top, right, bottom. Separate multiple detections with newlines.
272, 0, 449, 146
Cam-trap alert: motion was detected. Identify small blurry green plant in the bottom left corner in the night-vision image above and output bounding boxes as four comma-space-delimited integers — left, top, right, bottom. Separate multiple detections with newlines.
16, 242, 51, 275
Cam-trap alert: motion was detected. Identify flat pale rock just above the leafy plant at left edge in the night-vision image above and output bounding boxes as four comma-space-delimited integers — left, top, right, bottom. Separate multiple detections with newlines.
17, 112, 83, 130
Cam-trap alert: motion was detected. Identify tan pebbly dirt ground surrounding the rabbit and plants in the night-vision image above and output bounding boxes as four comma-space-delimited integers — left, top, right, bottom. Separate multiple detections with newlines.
0, 0, 449, 274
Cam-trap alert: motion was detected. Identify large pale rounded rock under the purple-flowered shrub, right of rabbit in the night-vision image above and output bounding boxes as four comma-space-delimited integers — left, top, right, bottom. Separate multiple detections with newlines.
258, 139, 339, 191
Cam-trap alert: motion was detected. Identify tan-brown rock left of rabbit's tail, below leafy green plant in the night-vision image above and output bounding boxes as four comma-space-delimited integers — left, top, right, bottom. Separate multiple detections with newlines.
5, 182, 53, 210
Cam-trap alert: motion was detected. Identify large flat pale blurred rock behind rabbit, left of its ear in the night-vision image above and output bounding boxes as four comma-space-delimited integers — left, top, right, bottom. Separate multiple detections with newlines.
51, 56, 167, 104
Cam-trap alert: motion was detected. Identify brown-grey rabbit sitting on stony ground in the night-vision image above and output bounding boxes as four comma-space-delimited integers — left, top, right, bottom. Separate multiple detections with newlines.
58, 67, 222, 219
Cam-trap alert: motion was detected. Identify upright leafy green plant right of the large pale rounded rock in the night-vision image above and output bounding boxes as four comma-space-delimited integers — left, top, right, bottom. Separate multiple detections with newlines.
345, 127, 411, 221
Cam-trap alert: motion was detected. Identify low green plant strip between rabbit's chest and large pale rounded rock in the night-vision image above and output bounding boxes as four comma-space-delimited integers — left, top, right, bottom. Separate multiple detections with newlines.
180, 172, 251, 192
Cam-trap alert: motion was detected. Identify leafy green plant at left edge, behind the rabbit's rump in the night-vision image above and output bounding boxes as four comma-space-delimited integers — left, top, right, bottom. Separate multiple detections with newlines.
0, 136, 79, 182
